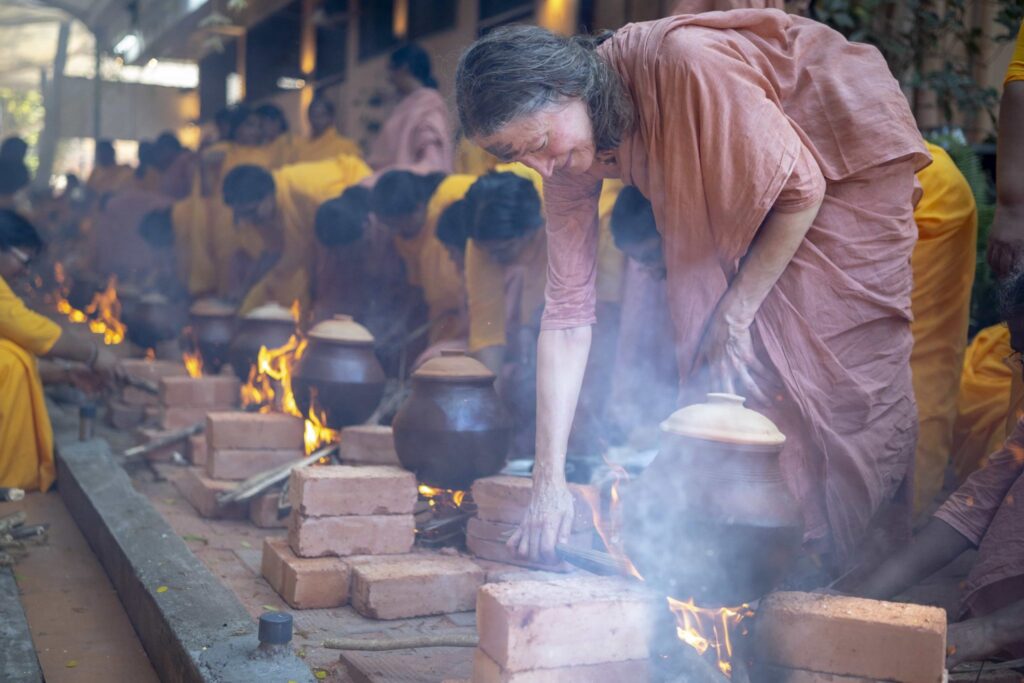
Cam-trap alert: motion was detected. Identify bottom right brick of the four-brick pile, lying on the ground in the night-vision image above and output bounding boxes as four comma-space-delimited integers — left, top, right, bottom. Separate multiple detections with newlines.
351, 555, 483, 618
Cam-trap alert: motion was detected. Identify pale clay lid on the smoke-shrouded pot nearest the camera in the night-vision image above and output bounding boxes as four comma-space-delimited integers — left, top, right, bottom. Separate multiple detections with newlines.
662, 393, 785, 447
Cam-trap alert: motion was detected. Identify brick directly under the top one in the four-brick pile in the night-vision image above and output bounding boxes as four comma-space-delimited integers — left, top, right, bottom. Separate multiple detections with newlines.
288, 510, 416, 557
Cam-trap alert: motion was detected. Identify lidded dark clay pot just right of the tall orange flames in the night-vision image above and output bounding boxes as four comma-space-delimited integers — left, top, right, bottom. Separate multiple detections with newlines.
292, 315, 386, 429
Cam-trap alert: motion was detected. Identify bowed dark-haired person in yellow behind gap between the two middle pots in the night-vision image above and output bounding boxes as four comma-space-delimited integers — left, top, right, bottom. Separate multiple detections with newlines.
371, 170, 468, 344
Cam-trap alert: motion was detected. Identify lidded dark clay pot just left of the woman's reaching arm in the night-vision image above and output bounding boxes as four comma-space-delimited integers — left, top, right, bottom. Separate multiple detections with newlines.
392, 352, 512, 490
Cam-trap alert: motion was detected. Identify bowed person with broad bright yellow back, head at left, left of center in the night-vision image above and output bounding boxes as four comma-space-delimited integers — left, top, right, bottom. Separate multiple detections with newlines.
223, 155, 371, 314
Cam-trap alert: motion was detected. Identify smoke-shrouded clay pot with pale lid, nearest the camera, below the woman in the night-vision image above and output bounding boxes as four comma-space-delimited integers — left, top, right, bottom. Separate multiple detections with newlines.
622, 394, 803, 606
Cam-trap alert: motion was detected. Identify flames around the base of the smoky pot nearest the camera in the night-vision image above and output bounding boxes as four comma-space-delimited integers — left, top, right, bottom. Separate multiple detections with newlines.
583, 461, 754, 678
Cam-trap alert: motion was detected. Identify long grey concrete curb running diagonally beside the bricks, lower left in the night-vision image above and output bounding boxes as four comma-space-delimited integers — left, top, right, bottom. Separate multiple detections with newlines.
56, 439, 311, 682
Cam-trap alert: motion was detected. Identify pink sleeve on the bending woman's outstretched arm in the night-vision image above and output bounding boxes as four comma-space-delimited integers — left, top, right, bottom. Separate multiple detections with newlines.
541, 176, 601, 330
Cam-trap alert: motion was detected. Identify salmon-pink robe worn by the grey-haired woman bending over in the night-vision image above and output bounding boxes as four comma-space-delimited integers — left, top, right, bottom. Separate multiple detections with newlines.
544, 9, 929, 561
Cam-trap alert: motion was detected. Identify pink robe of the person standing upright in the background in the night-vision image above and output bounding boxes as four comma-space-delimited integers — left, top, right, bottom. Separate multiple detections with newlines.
367, 87, 455, 173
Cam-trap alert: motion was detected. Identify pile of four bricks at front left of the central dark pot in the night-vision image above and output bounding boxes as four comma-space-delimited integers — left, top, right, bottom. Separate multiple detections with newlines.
262, 465, 483, 618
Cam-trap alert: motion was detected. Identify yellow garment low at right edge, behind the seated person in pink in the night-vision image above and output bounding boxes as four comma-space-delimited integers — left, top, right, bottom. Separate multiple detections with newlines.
952, 324, 1020, 482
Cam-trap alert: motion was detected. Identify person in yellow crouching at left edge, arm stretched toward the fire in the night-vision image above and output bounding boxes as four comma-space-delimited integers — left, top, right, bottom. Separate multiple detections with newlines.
0, 209, 123, 490
